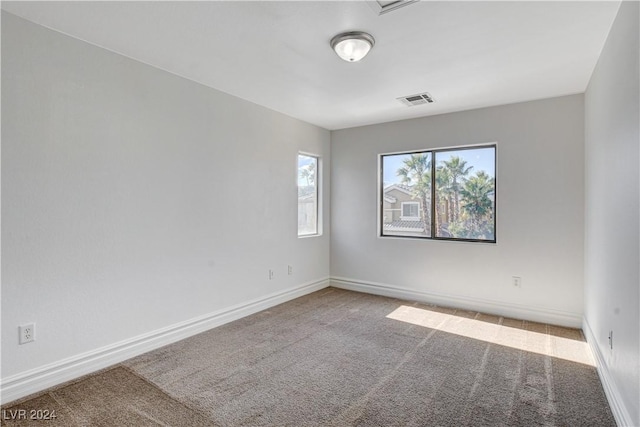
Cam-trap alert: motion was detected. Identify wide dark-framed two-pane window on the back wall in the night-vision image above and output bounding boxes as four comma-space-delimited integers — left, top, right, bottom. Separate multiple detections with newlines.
380, 145, 496, 242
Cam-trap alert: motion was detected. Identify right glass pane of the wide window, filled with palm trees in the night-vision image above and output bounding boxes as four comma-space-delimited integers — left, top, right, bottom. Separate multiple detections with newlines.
434, 147, 496, 240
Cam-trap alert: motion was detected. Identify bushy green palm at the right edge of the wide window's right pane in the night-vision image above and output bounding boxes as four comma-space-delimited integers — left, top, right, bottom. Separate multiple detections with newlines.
460, 171, 495, 235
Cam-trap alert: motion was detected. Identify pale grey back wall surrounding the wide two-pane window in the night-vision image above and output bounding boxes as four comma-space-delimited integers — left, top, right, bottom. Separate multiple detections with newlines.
331, 95, 584, 326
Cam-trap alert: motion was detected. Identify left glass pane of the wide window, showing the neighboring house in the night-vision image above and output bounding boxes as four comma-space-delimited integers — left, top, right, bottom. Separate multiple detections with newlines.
381, 152, 431, 237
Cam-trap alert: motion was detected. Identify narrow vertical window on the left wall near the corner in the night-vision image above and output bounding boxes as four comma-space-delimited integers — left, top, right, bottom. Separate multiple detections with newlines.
298, 154, 320, 236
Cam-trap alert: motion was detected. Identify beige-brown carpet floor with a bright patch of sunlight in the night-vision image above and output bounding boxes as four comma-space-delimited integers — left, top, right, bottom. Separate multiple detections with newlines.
2, 288, 615, 426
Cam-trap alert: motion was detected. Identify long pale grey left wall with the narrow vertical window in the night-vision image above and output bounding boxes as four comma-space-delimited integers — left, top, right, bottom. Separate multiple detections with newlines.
2, 12, 330, 394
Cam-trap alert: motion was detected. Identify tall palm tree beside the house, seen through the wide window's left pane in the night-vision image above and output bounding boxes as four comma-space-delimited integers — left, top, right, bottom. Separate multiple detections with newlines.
396, 154, 431, 235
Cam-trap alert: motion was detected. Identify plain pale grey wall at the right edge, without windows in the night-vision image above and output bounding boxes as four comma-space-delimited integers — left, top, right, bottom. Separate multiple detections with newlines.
584, 2, 640, 426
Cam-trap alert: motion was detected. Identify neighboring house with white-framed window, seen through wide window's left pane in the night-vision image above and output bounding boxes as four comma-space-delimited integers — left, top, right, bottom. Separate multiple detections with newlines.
382, 184, 424, 236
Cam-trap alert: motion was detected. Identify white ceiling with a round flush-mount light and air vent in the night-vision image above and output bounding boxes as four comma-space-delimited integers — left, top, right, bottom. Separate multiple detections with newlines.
2, 0, 620, 129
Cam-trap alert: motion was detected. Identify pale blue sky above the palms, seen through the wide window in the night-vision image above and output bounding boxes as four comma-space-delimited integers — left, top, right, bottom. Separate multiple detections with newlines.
382, 147, 495, 186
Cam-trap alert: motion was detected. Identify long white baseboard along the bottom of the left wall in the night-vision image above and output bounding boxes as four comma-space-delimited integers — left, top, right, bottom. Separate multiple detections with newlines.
0, 278, 329, 404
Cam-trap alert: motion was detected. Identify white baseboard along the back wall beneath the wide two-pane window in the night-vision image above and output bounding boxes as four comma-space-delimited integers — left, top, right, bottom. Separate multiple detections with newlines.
331, 277, 582, 328
